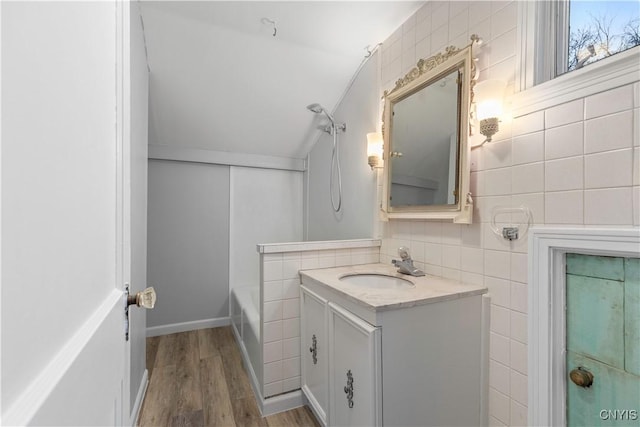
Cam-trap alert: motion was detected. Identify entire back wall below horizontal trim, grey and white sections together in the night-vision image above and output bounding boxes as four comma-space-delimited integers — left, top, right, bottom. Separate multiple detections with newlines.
147, 158, 302, 335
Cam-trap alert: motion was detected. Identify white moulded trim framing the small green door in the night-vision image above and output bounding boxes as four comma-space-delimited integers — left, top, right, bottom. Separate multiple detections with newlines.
528, 227, 640, 426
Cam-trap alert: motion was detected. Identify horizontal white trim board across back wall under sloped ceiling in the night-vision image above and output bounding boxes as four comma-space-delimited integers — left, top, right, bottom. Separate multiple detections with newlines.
149, 144, 305, 172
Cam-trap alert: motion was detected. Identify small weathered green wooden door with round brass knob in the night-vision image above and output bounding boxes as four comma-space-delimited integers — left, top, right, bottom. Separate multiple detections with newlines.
566, 254, 640, 427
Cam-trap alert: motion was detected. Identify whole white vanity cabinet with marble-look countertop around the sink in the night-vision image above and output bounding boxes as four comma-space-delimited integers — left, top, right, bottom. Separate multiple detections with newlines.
300, 264, 490, 426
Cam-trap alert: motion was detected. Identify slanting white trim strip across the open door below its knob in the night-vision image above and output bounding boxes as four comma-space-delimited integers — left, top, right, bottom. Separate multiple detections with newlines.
2, 289, 123, 425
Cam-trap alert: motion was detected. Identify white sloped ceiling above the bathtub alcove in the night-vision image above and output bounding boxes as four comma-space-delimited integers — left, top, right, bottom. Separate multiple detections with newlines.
140, 1, 423, 158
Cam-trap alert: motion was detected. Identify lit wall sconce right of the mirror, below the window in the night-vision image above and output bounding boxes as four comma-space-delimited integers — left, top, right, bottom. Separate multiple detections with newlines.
473, 80, 507, 142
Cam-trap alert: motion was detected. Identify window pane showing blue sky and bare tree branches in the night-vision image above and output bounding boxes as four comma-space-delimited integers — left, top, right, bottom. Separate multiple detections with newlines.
557, 0, 640, 74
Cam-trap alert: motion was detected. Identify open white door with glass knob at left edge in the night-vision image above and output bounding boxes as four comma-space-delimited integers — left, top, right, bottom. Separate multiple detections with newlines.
0, 1, 148, 425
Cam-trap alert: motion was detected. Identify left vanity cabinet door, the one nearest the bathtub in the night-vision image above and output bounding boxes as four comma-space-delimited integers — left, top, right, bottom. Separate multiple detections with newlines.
300, 286, 329, 426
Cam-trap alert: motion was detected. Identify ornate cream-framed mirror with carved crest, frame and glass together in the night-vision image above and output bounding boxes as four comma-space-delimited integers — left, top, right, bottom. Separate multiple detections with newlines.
381, 36, 477, 224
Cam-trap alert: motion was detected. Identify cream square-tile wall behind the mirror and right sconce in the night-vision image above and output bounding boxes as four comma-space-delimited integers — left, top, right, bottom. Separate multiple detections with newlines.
378, 1, 640, 426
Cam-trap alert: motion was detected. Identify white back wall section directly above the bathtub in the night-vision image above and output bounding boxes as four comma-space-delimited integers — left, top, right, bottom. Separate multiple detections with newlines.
229, 167, 302, 289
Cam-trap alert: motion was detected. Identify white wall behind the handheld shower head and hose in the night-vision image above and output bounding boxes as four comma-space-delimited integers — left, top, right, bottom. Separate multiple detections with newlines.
305, 51, 380, 241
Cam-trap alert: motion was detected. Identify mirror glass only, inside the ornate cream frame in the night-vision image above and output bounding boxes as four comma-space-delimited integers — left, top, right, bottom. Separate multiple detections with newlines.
389, 70, 461, 206
